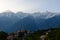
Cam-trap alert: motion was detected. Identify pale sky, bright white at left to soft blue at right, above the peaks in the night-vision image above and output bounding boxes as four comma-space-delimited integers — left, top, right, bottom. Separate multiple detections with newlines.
0, 0, 60, 12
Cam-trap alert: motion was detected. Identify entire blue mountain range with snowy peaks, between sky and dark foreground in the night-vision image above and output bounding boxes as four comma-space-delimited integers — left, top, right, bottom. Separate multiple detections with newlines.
0, 11, 60, 33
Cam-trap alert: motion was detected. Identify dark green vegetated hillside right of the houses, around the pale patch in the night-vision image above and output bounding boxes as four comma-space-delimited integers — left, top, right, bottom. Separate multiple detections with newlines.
25, 28, 60, 40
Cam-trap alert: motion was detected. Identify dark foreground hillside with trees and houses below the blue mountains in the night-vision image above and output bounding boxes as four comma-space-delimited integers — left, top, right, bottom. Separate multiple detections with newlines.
0, 28, 60, 40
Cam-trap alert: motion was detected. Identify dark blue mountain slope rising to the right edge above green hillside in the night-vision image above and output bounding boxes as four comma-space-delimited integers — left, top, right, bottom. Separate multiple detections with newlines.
41, 15, 60, 28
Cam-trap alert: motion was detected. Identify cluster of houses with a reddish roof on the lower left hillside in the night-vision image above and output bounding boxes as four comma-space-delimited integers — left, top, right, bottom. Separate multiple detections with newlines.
7, 30, 31, 40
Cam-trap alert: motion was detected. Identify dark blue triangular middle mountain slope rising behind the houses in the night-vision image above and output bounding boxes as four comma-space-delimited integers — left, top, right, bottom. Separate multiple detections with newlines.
13, 15, 38, 30
